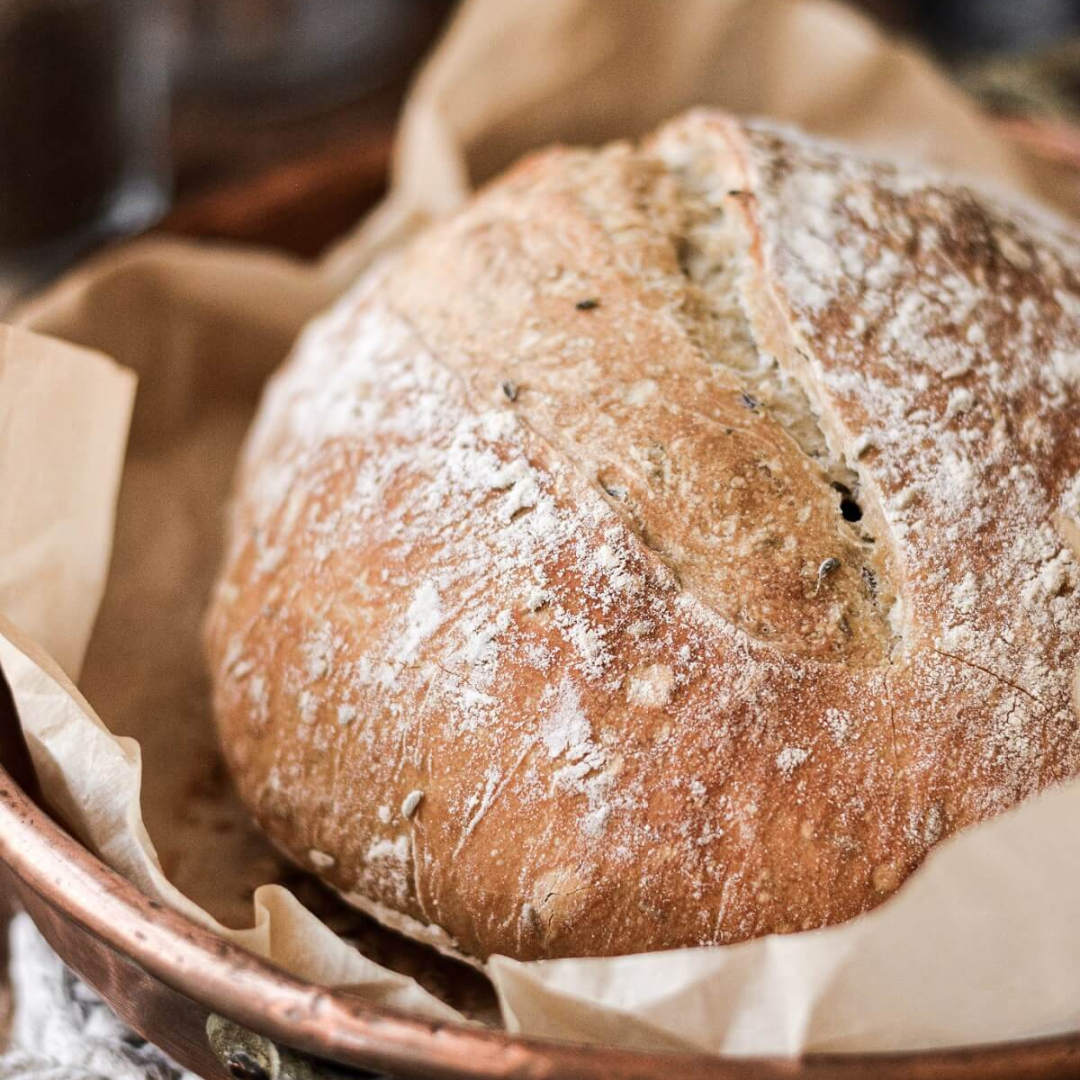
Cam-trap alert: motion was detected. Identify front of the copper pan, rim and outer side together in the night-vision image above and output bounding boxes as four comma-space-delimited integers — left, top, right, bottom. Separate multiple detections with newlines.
0, 677, 1080, 1080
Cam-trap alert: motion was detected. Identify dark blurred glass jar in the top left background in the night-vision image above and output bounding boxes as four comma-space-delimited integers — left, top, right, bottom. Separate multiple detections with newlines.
0, 0, 170, 253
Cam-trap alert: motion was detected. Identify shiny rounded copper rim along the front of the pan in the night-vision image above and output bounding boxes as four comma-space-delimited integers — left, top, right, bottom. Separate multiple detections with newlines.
0, 768, 1080, 1080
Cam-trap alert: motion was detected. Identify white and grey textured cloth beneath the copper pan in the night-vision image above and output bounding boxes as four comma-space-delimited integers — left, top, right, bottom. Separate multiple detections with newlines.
0, 915, 198, 1080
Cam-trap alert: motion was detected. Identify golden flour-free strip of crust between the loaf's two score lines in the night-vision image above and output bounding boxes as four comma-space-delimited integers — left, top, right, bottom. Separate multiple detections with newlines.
393, 135, 896, 665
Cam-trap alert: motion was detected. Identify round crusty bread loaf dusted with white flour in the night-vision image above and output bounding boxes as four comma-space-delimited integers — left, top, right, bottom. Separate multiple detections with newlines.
206, 112, 1080, 958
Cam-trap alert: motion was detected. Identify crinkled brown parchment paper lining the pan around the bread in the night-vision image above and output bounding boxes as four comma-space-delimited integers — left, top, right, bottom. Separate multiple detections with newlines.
0, 0, 1080, 1054
